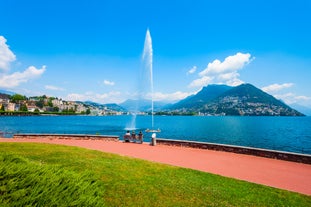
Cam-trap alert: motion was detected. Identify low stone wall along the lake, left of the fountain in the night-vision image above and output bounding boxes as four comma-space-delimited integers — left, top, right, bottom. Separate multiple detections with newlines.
13, 134, 119, 142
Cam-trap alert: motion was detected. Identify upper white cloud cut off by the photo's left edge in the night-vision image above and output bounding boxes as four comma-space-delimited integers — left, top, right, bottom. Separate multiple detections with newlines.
0, 36, 16, 71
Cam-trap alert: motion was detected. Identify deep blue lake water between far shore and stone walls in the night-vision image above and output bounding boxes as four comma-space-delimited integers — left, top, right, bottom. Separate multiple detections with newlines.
0, 116, 311, 154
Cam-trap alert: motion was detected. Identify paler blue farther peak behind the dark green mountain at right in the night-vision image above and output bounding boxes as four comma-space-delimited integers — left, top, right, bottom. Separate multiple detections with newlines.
169, 85, 232, 110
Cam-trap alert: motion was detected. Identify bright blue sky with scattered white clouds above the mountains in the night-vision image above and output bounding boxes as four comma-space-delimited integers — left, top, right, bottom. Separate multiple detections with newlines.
0, 0, 311, 107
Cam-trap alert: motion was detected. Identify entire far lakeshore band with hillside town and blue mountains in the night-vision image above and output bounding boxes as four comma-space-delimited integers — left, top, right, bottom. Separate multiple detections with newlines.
0, 84, 304, 116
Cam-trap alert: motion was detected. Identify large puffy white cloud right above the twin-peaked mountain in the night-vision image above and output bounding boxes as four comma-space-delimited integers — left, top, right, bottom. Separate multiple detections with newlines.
189, 52, 254, 88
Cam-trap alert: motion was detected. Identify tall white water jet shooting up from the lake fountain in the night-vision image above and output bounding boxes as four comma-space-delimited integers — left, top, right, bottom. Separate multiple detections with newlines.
142, 29, 154, 128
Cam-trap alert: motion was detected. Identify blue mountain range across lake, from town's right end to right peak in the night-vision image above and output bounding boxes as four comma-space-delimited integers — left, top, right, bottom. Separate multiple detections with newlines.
0, 83, 304, 116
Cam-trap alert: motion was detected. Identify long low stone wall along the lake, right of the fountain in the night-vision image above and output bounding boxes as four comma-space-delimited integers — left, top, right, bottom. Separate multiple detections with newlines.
156, 138, 311, 164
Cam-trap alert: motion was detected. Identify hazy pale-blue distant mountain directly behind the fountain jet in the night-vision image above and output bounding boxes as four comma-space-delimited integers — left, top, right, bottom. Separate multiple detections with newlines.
120, 99, 168, 112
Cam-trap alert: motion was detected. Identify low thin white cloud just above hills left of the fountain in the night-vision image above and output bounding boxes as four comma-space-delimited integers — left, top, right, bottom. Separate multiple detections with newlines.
65, 91, 123, 103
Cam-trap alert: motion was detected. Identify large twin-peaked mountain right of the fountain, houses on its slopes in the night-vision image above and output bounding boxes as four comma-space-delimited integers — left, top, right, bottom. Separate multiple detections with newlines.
171, 84, 303, 116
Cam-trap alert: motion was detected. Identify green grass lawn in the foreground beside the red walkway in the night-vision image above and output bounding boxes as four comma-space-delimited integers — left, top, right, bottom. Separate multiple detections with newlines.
0, 143, 311, 206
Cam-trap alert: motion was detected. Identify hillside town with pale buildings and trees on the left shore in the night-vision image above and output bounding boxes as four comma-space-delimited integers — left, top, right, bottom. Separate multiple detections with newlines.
0, 94, 123, 115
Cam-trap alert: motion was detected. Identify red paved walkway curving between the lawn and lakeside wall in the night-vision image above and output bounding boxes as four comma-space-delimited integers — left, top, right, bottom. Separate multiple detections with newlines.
0, 139, 311, 195
